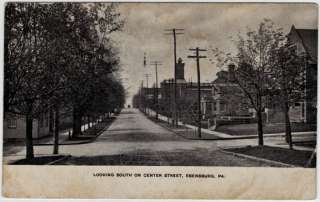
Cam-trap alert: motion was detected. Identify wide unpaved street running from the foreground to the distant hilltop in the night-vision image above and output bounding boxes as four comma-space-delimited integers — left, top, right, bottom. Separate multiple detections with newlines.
47, 109, 265, 166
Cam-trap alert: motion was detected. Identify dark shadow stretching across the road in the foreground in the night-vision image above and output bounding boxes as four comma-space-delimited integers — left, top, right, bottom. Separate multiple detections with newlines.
55, 148, 269, 167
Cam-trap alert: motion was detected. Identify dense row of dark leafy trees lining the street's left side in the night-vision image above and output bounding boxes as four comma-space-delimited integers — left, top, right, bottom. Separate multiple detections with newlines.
4, 3, 125, 158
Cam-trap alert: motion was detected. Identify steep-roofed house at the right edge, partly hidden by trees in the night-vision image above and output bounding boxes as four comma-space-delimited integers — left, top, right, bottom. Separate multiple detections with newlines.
266, 25, 318, 123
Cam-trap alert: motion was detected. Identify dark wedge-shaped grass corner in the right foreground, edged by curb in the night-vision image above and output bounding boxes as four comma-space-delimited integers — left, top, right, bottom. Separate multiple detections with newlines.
226, 146, 316, 168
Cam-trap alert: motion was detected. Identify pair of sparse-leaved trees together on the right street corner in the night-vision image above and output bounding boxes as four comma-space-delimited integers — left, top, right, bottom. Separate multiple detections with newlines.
213, 19, 306, 148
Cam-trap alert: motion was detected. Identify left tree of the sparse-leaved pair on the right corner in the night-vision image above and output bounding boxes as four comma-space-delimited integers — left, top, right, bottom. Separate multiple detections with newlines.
213, 19, 285, 146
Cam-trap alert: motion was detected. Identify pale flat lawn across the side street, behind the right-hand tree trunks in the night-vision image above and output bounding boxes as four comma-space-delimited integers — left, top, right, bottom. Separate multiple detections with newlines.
216, 123, 317, 135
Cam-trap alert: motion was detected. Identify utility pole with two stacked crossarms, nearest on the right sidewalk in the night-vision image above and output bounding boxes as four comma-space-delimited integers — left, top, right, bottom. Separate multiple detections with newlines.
188, 47, 207, 138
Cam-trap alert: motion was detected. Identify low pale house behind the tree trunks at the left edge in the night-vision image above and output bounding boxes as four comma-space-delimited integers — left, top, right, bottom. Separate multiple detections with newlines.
3, 113, 50, 142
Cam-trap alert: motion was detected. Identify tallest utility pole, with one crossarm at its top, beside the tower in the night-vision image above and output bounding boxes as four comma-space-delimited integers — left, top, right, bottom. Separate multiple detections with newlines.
165, 28, 184, 126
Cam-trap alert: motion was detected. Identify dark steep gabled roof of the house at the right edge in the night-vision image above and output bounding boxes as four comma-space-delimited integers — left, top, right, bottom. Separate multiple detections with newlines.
292, 26, 318, 62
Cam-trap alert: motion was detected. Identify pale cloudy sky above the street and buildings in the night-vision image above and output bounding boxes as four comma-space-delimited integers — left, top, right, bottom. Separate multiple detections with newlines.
111, 3, 318, 104
